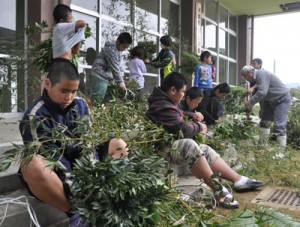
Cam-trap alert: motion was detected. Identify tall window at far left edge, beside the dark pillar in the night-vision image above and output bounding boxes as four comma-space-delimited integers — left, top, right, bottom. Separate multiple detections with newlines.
0, 0, 25, 112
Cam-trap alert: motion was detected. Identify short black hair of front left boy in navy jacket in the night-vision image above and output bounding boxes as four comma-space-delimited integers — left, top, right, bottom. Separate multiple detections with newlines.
47, 58, 79, 86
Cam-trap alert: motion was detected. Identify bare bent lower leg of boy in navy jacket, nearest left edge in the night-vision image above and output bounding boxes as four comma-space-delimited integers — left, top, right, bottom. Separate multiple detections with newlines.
21, 155, 72, 212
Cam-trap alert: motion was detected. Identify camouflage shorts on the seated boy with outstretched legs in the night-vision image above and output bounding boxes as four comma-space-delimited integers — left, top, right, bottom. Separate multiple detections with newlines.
163, 139, 220, 168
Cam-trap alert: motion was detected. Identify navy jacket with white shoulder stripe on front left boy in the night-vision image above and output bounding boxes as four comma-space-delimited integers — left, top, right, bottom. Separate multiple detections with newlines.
19, 90, 91, 169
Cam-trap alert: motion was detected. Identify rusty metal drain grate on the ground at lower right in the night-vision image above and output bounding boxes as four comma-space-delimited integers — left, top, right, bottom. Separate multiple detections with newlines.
251, 187, 300, 210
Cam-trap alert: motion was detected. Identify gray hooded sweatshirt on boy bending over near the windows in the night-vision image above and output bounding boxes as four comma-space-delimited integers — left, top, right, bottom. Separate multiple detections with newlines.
92, 42, 124, 84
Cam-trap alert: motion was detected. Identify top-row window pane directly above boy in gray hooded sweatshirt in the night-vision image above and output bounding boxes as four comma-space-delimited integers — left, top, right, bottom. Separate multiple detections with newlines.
101, 0, 131, 22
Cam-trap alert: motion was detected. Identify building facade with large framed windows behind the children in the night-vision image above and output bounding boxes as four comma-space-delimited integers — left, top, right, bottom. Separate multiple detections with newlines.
0, 0, 253, 113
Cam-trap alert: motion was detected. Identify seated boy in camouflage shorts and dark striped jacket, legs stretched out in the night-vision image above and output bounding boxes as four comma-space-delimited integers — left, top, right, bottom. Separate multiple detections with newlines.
146, 72, 262, 208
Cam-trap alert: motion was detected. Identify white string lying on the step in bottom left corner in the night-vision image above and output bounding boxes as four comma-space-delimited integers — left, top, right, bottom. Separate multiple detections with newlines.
0, 195, 41, 227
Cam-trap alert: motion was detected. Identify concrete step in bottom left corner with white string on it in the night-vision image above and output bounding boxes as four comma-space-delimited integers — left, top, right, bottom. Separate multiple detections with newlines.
0, 189, 68, 227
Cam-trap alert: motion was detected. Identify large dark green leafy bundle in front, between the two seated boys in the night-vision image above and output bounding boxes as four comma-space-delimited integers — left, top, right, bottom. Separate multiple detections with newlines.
73, 148, 187, 226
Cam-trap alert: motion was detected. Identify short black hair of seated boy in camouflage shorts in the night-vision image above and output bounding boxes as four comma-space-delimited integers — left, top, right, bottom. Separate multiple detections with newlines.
161, 72, 187, 92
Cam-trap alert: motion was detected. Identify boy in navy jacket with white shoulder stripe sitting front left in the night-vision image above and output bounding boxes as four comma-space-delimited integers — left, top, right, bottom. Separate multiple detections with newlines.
19, 59, 127, 226
